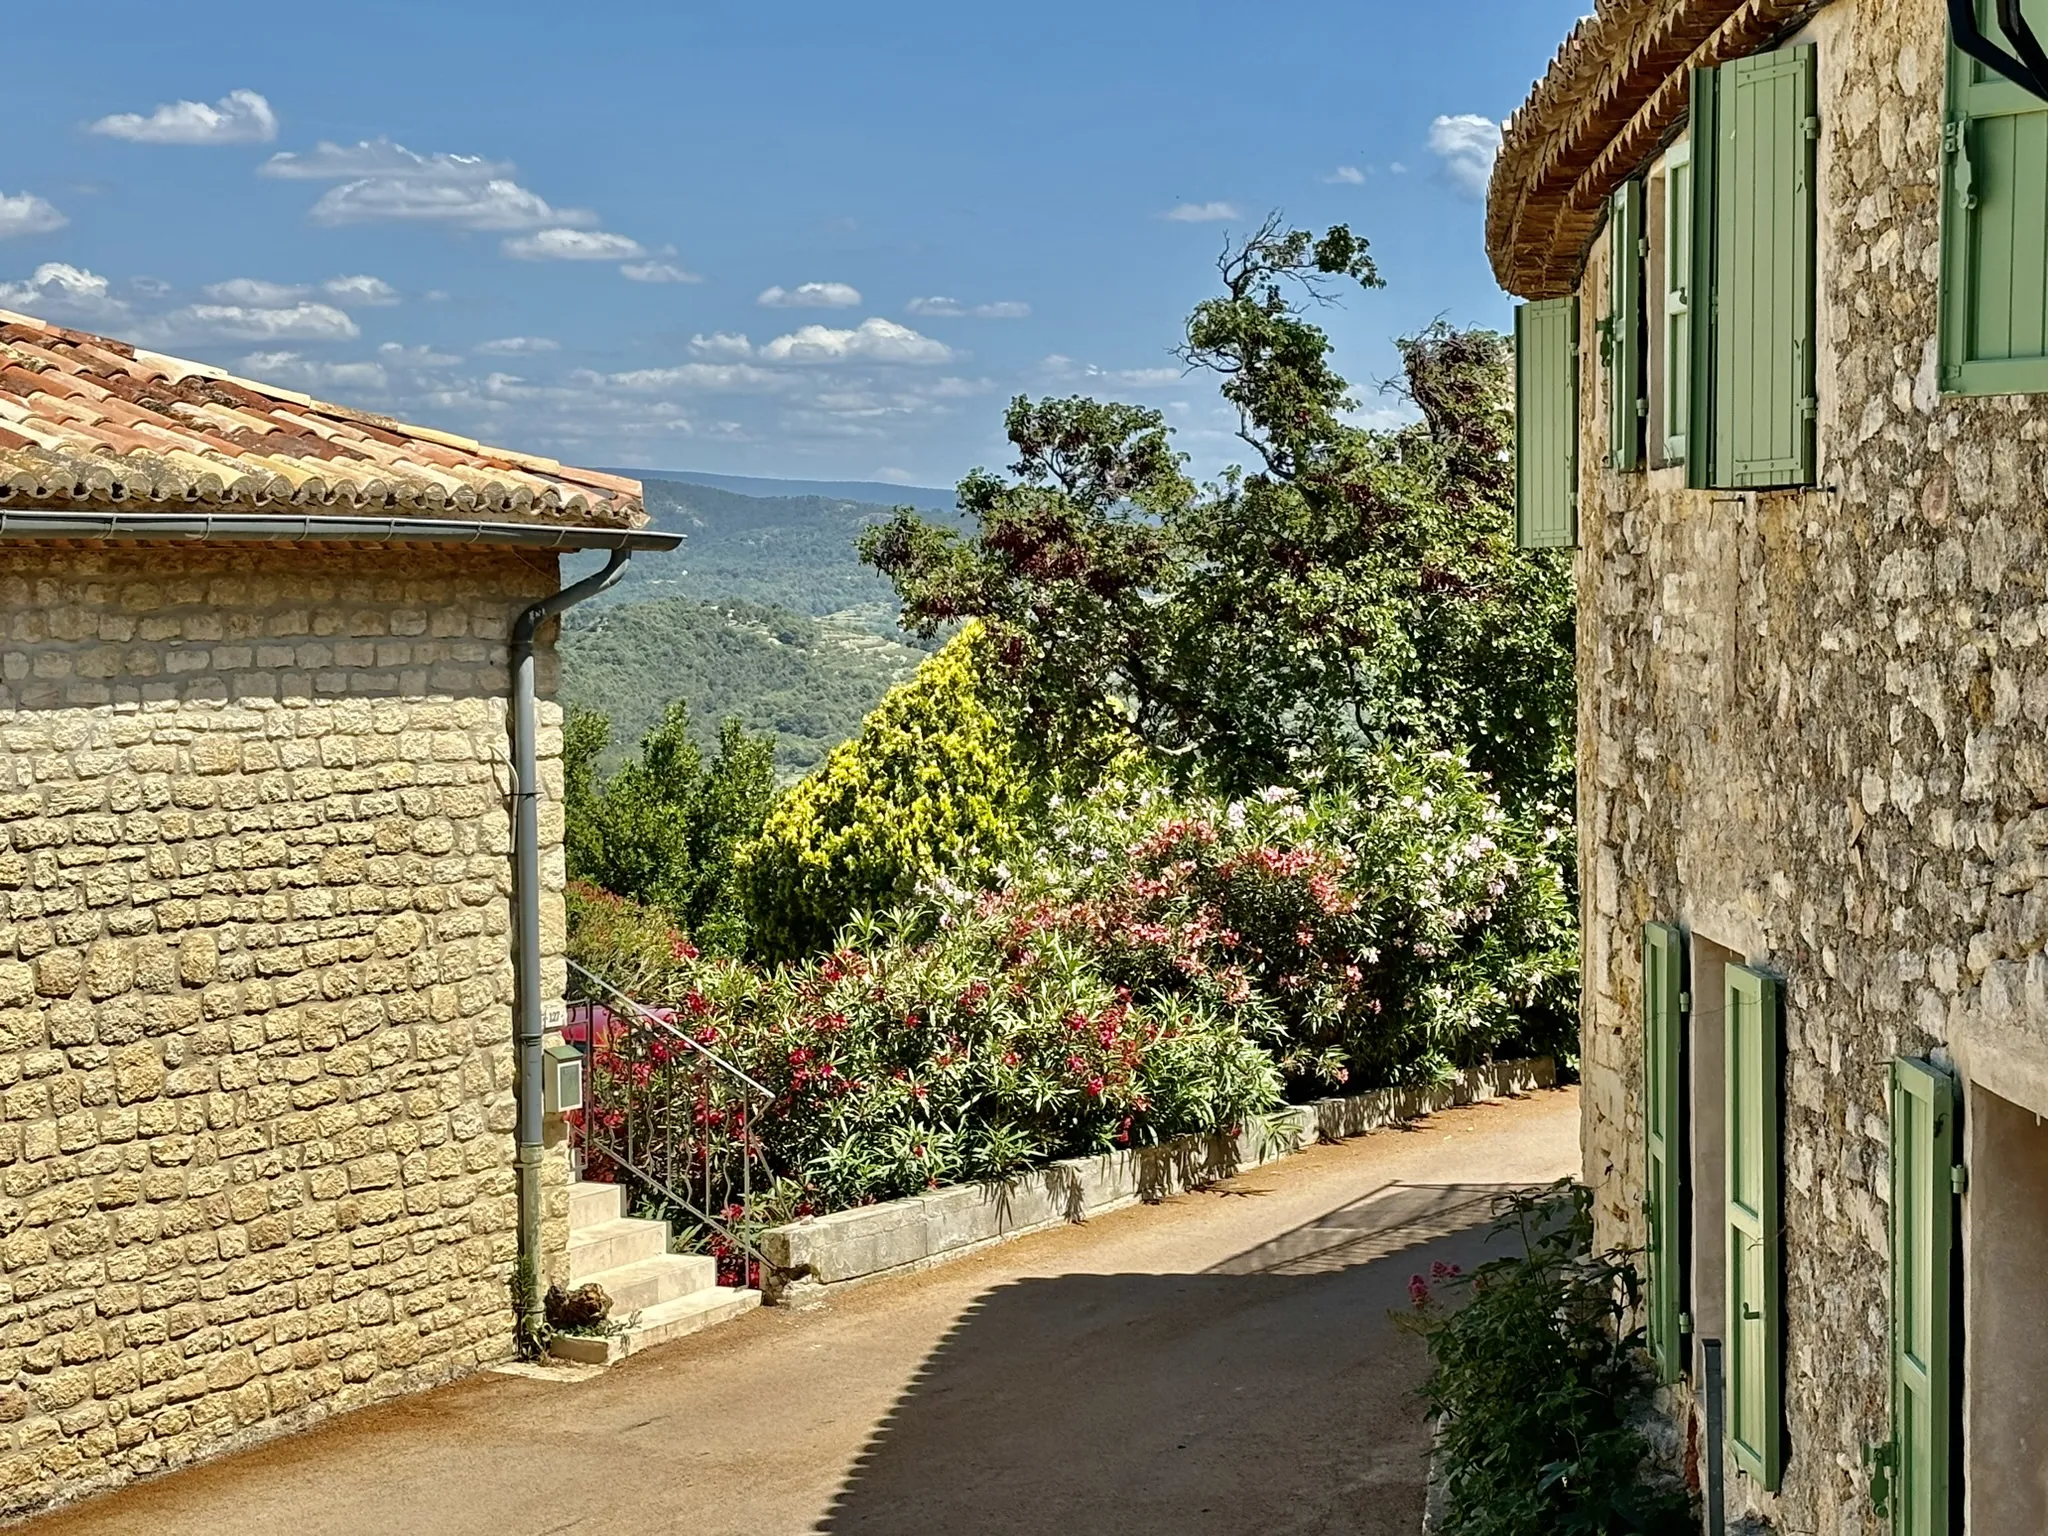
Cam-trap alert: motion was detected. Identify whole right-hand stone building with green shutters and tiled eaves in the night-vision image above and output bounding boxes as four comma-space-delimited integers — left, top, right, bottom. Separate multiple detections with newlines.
1487, 0, 2048, 1536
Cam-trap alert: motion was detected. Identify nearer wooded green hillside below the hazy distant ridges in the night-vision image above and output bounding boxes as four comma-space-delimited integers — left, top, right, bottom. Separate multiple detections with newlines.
561, 593, 930, 780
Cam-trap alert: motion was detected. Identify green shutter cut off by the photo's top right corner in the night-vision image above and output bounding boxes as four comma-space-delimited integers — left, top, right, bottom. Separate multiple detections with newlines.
1942, 0, 2048, 395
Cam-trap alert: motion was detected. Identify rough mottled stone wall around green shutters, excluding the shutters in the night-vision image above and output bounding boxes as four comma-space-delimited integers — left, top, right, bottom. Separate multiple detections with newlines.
1579, 0, 2048, 1536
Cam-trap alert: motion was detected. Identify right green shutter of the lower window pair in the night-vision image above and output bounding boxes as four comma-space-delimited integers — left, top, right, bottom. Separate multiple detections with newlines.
1722, 965, 1784, 1493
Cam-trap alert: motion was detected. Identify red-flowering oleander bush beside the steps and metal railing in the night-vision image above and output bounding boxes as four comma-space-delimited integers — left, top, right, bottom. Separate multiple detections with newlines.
571, 893, 1280, 1225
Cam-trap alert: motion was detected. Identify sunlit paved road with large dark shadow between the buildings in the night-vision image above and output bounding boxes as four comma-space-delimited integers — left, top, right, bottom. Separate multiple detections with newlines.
25, 1092, 1579, 1536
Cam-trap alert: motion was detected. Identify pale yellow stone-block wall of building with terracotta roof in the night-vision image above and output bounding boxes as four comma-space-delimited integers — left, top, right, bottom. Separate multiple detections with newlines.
0, 545, 567, 1511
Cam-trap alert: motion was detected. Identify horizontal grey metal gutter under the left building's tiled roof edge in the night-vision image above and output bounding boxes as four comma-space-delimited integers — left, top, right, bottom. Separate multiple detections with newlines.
0, 510, 682, 551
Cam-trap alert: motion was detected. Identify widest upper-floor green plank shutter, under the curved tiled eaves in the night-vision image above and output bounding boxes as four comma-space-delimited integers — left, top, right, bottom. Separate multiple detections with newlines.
1688, 45, 1821, 489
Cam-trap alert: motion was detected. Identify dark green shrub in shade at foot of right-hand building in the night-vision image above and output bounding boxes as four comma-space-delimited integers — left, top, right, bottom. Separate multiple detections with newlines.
1409, 1180, 1698, 1536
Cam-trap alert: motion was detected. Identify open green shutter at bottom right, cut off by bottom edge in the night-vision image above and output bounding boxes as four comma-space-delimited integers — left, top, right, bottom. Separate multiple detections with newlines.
1892, 1061, 1956, 1536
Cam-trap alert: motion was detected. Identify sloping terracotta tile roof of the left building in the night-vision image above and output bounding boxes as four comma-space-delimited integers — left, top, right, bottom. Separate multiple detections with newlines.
0, 309, 647, 528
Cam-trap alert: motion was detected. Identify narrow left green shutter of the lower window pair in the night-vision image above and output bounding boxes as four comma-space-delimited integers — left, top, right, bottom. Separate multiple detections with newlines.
1642, 924, 1686, 1382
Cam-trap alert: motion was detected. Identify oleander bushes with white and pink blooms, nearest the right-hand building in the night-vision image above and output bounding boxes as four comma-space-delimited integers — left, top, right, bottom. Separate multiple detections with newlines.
952, 752, 1579, 1098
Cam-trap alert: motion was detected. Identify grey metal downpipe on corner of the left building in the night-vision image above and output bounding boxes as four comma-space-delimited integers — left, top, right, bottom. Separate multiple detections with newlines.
512, 549, 633, 1337
